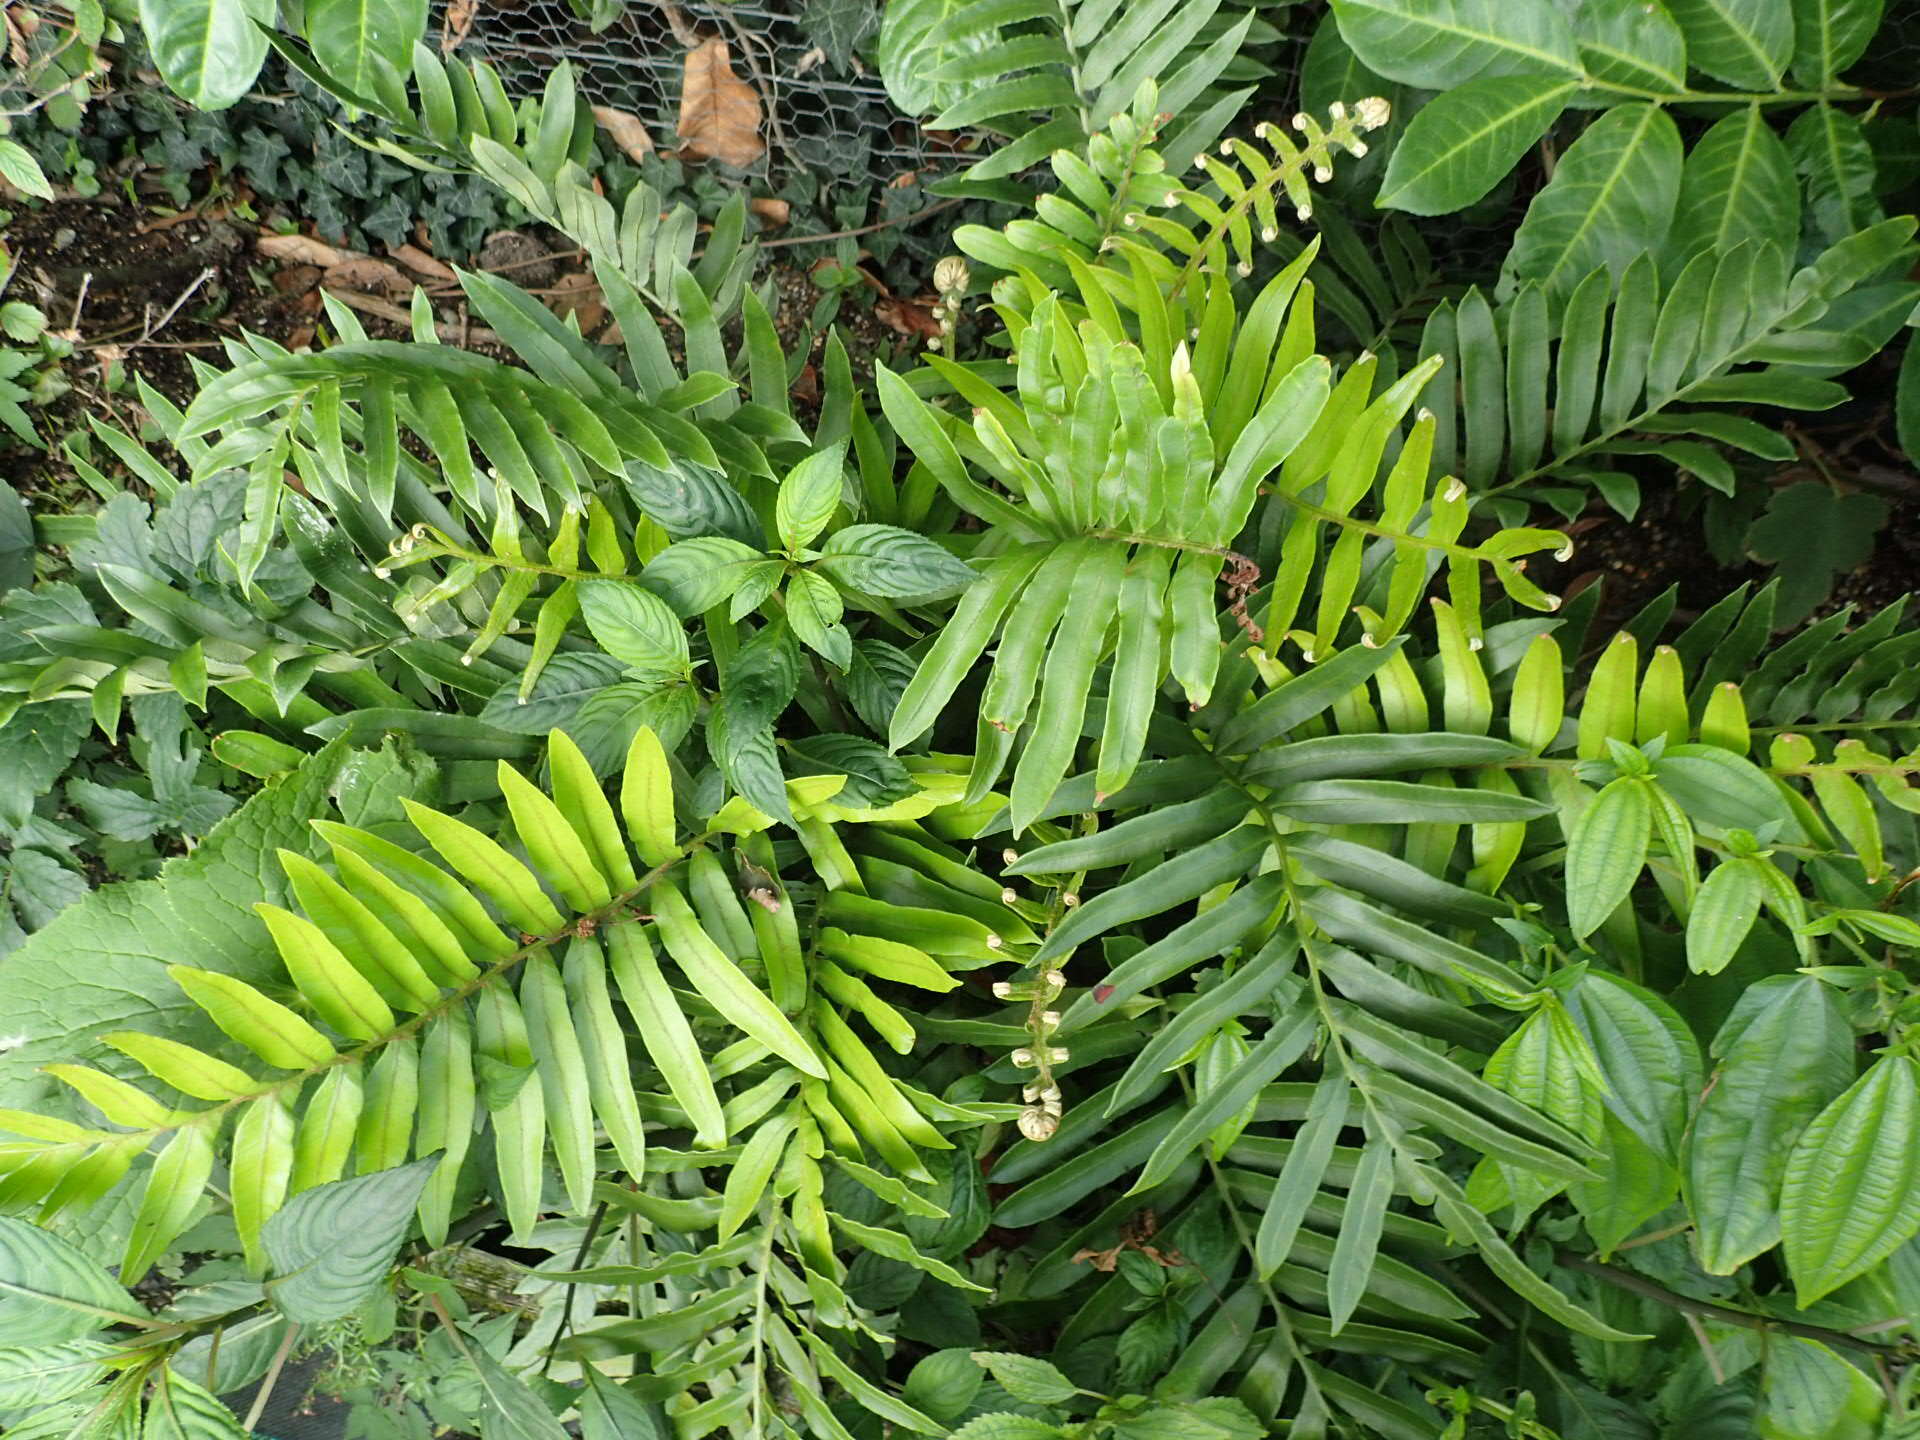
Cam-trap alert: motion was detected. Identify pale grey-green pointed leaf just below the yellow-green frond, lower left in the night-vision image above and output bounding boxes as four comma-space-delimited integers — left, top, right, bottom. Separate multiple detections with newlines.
261, 1156, 440, 1325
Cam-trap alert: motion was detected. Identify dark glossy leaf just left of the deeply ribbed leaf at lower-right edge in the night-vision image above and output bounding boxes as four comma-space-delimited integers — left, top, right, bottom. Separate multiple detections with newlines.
1682, 975, 1853, 1275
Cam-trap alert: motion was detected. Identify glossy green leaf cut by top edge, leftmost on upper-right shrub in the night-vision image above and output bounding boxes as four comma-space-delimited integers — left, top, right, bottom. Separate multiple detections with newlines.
1332, 0, 1580, 90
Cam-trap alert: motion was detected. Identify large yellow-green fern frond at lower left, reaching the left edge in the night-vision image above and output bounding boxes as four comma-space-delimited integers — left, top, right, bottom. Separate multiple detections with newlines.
0, 732, 990, 1279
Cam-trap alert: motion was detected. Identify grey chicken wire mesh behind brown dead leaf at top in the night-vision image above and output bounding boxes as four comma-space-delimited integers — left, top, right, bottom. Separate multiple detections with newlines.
440, 0, 944, 180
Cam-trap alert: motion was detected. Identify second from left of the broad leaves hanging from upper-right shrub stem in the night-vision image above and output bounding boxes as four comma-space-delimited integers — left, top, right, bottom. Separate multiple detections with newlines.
1497, 102, 1682, 298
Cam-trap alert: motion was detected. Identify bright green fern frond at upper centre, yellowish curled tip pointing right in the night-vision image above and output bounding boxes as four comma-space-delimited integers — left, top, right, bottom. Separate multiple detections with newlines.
879, 253, 1563, 828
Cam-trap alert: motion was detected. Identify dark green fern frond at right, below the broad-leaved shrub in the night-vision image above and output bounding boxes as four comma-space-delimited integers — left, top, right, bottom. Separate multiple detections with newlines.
1421, 217, 1920, 503
